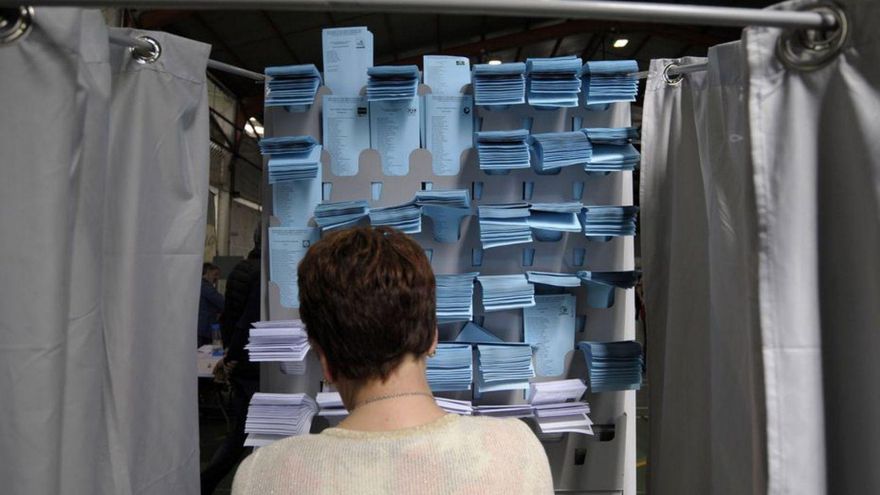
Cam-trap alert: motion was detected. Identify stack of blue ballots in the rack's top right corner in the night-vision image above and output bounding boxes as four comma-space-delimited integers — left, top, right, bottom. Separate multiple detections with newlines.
583, 60, 639, 105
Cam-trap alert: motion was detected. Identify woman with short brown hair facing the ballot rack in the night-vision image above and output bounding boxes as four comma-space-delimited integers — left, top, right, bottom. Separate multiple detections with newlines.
232, 227, 553, 495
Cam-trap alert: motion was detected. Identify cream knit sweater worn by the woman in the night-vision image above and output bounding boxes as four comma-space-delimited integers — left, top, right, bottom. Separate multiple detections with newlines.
232, 414, 553, 495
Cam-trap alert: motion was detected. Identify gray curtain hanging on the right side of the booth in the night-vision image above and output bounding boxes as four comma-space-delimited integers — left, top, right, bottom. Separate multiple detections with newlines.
641, 0, 880, 494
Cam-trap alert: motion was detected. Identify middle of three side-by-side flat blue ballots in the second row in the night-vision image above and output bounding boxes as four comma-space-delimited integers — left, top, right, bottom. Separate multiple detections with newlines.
370, 97, 421, 175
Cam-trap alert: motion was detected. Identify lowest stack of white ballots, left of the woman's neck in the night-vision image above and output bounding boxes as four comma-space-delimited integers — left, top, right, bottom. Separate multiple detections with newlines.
244, 392, 318, 447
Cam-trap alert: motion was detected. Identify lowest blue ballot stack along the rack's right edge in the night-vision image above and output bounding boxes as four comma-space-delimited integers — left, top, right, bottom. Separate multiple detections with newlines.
578, 340, 644, 392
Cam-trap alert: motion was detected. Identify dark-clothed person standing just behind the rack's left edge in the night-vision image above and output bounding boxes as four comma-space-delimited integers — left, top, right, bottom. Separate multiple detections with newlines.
200, 231, 260, 495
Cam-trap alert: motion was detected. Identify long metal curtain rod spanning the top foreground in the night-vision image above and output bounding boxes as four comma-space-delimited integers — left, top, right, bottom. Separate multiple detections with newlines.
0, 0, 837, 29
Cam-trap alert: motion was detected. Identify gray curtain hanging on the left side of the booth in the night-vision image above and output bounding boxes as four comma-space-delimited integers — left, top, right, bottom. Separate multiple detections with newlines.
0, 8, 209, 494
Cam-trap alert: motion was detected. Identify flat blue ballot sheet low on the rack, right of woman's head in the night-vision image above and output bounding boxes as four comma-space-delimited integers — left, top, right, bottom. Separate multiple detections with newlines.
523, 294, 575, 376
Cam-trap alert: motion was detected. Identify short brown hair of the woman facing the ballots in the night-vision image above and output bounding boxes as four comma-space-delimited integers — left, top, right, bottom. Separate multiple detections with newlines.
298, 227, 437, 380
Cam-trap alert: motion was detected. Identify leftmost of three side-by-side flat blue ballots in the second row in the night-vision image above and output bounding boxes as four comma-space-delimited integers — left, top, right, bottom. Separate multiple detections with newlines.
321, 95, 370, 176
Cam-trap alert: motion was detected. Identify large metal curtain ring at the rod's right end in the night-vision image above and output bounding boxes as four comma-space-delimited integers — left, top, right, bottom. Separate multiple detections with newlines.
776, 3, 850, 71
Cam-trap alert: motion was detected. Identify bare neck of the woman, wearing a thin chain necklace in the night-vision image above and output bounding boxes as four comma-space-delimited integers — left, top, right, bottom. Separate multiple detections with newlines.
338, 356, 446, 431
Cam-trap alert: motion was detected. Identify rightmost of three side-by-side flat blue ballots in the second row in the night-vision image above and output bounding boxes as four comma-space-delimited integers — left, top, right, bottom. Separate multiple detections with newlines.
424, 95, 474, 176
